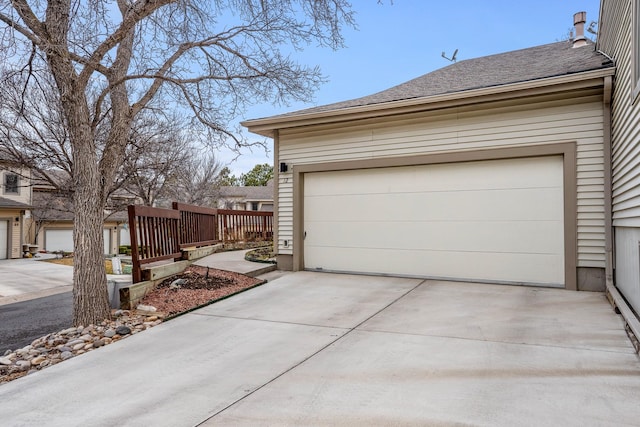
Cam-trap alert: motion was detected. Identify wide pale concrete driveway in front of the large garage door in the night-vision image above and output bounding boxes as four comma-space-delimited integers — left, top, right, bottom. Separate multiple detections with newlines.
0, 272, 640, 426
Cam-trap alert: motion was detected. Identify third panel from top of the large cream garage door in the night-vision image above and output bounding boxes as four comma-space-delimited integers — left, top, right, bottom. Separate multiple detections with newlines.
305, 221, 564, 255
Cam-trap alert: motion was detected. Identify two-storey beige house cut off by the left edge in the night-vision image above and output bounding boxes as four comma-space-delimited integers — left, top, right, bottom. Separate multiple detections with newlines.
0, 159, 31, 260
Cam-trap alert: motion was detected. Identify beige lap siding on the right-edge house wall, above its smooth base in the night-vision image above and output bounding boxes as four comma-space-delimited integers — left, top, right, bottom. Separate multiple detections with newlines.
598, 0, 640, 227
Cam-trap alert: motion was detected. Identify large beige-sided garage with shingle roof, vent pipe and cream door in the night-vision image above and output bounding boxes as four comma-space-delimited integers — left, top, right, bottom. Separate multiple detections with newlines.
243, 14, 612, 290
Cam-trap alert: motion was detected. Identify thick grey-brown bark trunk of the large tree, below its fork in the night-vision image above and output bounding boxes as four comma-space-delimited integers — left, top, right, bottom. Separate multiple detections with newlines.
73, 144, 111, 326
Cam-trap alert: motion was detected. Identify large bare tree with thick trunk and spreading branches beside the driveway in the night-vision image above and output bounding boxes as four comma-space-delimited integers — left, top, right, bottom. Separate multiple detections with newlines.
0, 0, 353, 324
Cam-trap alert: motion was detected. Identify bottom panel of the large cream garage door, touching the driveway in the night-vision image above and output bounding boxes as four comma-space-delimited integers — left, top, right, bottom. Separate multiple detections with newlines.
305, 247, 564, 287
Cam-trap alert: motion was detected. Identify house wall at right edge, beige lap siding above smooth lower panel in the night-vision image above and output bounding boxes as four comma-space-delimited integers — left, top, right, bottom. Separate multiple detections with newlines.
597, 0, 640, 313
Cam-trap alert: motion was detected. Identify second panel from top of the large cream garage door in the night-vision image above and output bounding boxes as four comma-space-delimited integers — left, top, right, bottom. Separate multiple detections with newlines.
305, 187, 563, 222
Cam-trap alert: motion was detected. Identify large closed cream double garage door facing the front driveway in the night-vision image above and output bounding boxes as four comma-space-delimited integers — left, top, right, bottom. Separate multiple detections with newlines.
304, 156, 564, 287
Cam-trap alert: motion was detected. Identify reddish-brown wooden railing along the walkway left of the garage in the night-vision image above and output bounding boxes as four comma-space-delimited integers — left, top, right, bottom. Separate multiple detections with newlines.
128, 203, 273, 283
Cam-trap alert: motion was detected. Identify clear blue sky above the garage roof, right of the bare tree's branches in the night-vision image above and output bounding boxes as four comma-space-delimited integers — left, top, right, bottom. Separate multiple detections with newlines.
218, 0, 600, 174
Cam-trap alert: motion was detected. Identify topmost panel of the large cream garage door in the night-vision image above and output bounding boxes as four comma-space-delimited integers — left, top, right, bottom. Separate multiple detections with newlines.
305, 157, 562, 196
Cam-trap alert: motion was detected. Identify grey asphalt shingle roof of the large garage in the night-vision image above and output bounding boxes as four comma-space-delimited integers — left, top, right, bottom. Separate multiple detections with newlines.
262, 41, 614, 118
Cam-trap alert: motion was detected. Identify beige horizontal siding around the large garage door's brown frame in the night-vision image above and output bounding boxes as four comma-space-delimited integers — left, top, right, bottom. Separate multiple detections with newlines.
278, 91, 605, 267
